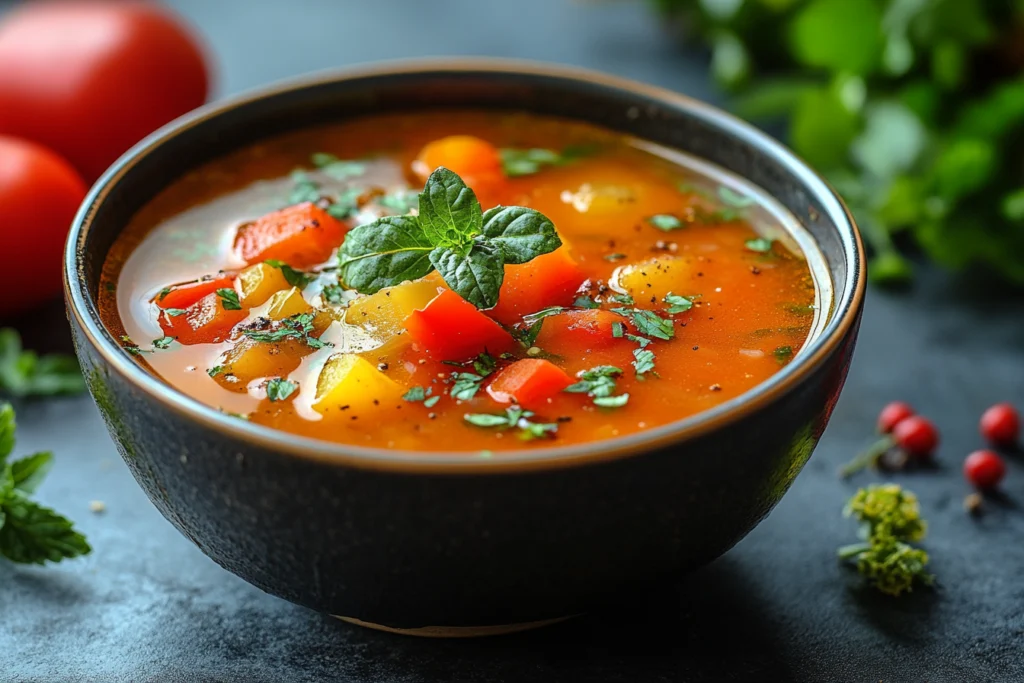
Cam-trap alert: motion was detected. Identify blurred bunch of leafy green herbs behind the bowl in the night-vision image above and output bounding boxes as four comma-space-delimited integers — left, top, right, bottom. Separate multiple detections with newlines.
651, 0, 1024, 285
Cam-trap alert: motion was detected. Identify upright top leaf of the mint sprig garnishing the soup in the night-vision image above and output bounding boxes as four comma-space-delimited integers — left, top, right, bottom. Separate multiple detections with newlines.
419, 167, 483, 250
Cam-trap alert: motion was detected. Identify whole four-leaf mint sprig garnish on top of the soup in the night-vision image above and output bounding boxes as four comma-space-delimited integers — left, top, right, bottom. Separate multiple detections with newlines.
339, 168, 562, 309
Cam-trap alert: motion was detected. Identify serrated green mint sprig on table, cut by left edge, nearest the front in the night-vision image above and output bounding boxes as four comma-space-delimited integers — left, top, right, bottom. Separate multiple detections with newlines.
0, 403, 92, 564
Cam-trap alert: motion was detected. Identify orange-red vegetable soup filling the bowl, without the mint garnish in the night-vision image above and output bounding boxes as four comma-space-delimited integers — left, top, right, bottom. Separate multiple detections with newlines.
100, 112, 819, 455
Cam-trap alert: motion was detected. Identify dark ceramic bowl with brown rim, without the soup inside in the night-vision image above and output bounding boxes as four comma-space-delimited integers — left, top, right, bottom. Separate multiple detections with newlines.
66, 60, 864, 634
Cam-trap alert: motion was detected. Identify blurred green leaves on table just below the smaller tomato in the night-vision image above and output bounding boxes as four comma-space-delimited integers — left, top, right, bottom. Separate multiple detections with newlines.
0, 328, 85, 397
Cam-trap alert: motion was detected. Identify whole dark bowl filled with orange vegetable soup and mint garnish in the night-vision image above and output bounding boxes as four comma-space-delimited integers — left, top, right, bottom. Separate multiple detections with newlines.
66, 59, 864, 635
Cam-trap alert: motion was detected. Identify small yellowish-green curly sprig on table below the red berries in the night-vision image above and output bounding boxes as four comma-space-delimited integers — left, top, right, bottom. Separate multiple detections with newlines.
839, 483, 935, 596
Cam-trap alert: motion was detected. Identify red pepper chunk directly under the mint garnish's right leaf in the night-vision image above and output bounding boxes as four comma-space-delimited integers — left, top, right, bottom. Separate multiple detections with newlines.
487, 247, 587, 325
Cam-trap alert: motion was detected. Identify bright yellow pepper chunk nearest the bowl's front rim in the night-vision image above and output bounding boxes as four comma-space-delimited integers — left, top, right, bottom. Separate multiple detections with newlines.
313, 353, 403, 417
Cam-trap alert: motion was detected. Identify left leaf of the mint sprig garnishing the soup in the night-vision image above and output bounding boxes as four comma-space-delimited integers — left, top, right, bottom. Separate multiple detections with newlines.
339, 216, 434, 294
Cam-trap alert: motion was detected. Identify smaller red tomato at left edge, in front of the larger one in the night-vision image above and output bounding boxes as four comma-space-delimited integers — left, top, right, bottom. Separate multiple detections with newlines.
0, 135, 85, 317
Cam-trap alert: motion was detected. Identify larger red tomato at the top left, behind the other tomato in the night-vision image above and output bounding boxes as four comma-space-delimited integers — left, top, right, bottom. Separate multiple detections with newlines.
0, 0, 208, 182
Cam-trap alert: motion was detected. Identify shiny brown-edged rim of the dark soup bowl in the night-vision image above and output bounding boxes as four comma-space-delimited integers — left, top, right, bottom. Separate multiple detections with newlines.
63, 57, 865, 474
